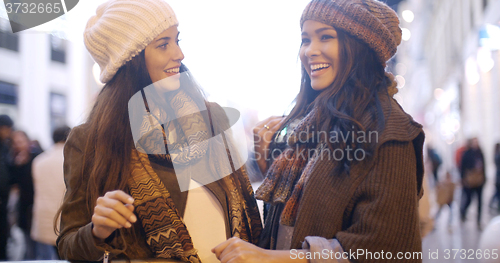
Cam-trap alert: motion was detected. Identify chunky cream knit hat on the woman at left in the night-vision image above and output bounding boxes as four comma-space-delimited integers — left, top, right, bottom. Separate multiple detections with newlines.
84, 0, 179, 83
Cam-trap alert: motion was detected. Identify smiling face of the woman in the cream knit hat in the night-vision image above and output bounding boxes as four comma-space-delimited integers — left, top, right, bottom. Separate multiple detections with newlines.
144, 26, 184, 92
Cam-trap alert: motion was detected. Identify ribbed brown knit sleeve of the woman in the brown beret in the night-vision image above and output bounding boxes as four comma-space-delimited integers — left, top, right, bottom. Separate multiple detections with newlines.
335, 141, 423, 262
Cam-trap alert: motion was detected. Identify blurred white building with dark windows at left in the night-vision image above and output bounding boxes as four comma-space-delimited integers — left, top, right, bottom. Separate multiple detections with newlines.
0, 18, 97, 151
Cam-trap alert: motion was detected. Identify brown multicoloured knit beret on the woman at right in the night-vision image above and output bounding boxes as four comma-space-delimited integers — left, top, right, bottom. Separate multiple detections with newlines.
300, 0, 402, 65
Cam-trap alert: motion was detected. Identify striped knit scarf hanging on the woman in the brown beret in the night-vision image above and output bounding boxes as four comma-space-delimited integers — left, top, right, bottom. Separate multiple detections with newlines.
255, 109, 316, 226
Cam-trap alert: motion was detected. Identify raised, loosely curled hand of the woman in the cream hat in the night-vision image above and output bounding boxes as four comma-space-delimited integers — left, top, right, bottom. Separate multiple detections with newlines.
92, 190, 137, 240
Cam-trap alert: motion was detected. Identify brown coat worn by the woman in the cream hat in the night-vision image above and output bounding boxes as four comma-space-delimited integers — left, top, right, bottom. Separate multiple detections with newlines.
56, 104, 261, 261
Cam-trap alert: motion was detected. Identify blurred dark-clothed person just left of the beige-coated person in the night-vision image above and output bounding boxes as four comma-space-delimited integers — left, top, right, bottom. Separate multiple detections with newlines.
10, 130, 41, 260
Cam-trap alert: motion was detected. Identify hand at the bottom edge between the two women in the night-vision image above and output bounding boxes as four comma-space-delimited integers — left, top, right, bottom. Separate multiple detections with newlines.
212, 237, 272, 263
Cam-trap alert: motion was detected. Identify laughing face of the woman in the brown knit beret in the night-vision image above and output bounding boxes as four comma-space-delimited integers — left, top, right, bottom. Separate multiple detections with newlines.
300, 20, 340, 91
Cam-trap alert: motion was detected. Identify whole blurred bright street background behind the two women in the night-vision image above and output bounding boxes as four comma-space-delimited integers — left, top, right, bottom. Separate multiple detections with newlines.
0, 0, 500, 262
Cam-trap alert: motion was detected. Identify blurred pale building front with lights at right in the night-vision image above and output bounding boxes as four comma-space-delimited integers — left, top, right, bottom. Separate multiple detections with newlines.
393, 0, 500, 179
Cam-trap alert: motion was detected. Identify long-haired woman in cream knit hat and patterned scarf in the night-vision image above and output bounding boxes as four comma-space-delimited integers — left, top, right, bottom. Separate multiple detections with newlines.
57, 0, 262, 263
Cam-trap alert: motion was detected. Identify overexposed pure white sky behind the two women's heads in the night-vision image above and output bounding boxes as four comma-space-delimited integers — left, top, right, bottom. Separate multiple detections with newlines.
0, 0, 310, 120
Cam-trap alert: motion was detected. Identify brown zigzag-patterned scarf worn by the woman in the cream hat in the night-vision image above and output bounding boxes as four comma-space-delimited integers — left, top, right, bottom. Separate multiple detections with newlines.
128, 91, 262, 263
